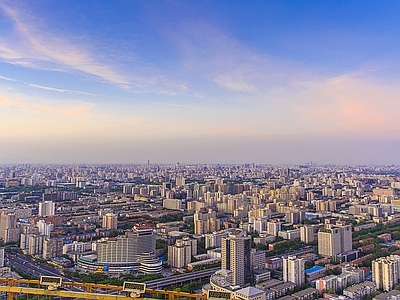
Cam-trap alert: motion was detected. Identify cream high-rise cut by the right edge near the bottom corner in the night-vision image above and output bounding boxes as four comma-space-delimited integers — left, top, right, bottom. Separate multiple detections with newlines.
372, 255, 400, 292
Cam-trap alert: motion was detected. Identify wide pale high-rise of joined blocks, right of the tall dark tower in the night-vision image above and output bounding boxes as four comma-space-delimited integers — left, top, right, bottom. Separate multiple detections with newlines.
318, 224, 352, 257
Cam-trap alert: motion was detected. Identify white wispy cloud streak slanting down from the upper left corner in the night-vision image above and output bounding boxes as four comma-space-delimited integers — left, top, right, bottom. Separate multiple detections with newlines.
0, 3, 128, 86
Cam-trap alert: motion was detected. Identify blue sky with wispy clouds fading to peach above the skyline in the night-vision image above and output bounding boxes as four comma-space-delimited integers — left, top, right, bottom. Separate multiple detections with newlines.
0, 0, 400, 165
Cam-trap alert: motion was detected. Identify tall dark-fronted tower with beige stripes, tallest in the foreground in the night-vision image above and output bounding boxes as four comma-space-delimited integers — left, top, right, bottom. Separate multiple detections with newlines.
222, 230, 254, 286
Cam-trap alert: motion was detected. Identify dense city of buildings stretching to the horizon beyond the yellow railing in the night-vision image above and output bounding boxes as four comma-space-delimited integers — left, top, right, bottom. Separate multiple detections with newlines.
0, 162, 400, 300
